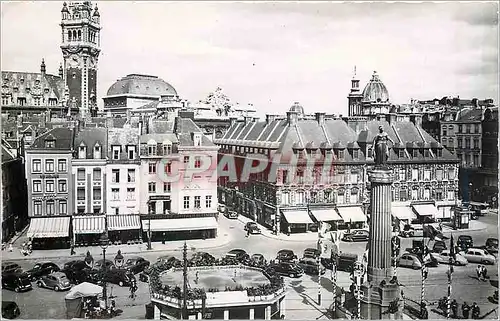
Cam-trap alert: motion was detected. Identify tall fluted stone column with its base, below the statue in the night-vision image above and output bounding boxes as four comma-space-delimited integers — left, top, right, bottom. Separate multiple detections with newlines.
361, 166, 403, 319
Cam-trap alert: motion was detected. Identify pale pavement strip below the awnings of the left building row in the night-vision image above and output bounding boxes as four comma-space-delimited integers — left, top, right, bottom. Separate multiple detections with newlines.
1, 226, 231, 260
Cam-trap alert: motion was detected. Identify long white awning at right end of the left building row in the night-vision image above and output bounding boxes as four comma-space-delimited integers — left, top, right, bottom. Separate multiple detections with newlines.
142, 217, 218, 232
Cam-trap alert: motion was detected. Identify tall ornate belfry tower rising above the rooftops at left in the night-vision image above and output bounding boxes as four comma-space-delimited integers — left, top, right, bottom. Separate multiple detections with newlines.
61, 1, 101, 118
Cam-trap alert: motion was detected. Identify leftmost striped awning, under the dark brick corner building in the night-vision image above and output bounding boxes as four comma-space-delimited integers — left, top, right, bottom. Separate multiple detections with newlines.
26, 216, 71, 238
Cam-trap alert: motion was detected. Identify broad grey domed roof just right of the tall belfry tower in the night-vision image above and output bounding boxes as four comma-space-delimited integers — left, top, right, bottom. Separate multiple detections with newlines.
107, 74, 177, 97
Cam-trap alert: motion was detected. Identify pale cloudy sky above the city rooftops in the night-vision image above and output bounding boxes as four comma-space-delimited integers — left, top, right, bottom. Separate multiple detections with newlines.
1, 1, 499, 116
